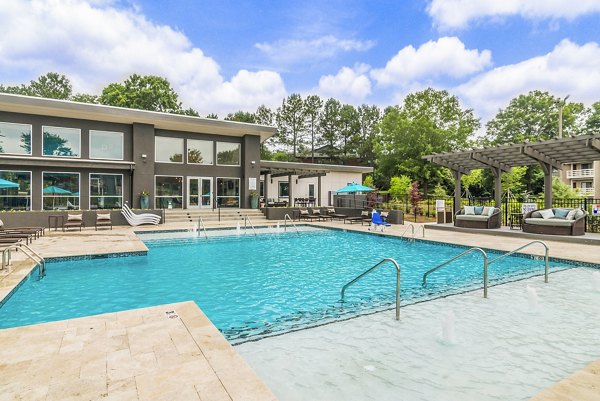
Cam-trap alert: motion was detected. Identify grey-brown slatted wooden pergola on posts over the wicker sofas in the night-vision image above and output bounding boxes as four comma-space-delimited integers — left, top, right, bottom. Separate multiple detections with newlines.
423, 135, 600, 212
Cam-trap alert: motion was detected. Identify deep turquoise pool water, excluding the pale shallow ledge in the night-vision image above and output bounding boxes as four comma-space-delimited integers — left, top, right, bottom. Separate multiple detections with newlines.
0, 230, 572, 343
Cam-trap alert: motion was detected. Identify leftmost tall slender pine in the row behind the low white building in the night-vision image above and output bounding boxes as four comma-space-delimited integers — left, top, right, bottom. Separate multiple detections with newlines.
275, 93, 306, 158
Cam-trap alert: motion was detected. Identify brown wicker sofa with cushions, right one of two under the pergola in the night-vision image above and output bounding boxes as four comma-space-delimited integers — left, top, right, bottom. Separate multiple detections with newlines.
523, 208, 587, 235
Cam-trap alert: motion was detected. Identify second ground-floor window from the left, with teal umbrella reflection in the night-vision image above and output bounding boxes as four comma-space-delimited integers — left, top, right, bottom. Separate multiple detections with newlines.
42, 172, 79, 210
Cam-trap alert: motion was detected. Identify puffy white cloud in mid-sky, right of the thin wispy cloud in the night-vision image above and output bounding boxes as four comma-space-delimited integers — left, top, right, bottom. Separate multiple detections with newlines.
371, 37, 492, 86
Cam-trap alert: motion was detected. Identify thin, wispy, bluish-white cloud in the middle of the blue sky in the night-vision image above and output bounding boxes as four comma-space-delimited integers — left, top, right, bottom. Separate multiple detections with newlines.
254, 35, 375, 64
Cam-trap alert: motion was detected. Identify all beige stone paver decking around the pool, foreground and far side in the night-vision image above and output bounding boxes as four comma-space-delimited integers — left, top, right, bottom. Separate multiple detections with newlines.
0, 221, 600, 401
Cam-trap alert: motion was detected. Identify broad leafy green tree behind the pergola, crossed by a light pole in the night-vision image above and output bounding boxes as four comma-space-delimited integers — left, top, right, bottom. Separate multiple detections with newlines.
485, 90, 585, 145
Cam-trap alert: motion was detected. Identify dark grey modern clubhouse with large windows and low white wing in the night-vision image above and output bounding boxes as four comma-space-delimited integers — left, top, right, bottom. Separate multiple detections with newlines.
0, 94, 373, 210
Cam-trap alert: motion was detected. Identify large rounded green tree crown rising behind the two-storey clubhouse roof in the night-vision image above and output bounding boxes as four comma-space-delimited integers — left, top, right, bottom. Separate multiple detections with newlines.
99, 74, 181, 113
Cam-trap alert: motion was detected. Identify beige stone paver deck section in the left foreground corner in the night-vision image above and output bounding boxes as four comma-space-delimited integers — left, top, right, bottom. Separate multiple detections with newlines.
0, 302, 275, 401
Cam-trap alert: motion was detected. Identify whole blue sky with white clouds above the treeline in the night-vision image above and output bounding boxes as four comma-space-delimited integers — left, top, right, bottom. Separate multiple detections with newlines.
0, 0, 600, 122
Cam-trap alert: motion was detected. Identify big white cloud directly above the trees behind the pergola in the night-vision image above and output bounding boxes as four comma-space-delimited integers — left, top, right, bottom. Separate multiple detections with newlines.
452, 40, 600, 120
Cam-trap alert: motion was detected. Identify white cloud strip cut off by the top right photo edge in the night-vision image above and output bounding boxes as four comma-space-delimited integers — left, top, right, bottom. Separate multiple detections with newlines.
427, 0, 600, 29
